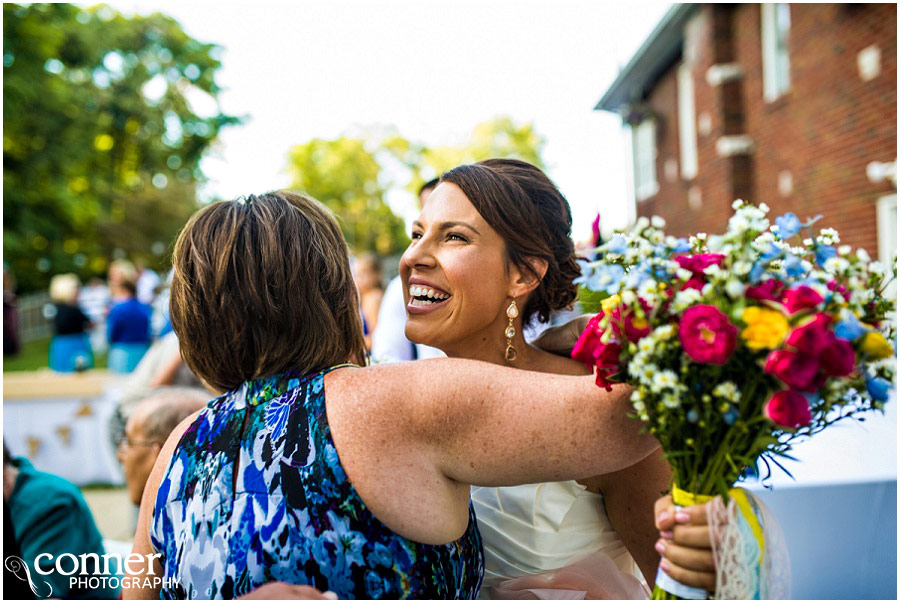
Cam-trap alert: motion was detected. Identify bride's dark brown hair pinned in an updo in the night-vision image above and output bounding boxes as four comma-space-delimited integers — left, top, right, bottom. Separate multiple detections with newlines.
441, 159, 581, 324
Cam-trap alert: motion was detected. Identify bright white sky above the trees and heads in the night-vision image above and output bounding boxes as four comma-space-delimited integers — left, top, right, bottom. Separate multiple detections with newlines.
98, 0, 671, 240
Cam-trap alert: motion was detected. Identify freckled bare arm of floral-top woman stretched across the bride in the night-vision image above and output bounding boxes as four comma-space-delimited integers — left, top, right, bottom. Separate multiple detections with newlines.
330, 359, 658, 486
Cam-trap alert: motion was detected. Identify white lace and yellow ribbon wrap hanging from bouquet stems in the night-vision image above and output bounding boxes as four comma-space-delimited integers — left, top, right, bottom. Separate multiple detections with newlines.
706, 489, 791, 599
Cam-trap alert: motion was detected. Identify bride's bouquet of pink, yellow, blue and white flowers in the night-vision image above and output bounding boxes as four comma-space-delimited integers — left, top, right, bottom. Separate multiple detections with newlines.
572, 201, 896, 598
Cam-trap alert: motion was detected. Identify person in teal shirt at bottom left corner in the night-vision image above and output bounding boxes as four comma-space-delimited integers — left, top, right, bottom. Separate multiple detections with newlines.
3, 445, 119, 599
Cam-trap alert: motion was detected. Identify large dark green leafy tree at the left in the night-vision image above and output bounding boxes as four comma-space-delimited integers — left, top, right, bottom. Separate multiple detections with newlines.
3, 4, 239, 290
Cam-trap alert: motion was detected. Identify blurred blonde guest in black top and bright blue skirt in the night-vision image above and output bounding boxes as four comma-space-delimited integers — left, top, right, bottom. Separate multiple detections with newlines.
50, 273, 94, 373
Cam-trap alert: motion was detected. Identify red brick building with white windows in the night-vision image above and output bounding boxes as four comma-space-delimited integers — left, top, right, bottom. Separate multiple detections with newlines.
597, 4, 897, 259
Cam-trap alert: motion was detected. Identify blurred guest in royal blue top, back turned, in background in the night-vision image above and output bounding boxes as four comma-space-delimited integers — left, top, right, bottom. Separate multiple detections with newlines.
106, 279, 153, 373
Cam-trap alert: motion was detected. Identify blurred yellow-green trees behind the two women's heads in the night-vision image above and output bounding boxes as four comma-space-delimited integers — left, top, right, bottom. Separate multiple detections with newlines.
288, 117, 544, 255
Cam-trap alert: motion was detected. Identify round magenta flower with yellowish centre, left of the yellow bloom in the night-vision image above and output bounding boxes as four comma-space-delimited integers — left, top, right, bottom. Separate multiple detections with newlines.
678, 305, 738, 364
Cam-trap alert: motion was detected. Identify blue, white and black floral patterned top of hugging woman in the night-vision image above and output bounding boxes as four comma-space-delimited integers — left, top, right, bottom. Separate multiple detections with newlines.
150, 367, 484, 599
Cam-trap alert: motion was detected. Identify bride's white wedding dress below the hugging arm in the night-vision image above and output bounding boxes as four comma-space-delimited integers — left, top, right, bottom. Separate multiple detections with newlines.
472, 481, 650, 599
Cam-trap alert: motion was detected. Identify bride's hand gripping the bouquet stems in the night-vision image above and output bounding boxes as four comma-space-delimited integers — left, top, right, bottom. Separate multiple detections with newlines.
654, 495, 716, 592
